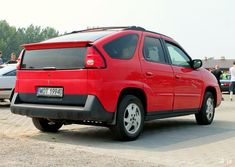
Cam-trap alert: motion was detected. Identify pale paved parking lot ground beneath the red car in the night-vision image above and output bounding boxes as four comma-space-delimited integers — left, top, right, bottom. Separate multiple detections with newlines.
0, 95, 235, 167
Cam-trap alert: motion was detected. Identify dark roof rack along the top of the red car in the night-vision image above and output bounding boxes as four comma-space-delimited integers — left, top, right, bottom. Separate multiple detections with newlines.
69, 26, 145, 34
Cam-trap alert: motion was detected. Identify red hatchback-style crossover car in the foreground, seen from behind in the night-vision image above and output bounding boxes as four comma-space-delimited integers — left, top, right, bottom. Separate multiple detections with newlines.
11, 26, 221, 140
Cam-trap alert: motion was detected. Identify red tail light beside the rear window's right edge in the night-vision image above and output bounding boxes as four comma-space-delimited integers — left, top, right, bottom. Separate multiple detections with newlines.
85, 46, 106, 68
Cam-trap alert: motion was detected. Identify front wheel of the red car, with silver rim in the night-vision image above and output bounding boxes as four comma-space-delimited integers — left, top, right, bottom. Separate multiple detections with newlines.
195, 92, 215, 125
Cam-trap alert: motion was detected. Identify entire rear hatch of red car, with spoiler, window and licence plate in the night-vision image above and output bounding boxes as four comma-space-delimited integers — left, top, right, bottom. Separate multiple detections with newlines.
16, 41, 90, 106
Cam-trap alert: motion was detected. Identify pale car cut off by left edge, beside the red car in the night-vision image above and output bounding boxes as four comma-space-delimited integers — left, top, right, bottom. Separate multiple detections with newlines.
0, 64, 16, 101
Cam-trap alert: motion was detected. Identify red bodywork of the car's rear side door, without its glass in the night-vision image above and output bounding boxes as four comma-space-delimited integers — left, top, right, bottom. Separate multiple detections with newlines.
139, 33, 174, 112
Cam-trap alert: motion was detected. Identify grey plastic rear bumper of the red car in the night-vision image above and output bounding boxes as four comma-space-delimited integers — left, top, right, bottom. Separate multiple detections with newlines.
11, 93, 114, 123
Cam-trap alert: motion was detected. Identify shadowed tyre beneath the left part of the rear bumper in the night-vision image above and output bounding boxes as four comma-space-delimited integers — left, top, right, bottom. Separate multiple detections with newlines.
32, 118, 63, 132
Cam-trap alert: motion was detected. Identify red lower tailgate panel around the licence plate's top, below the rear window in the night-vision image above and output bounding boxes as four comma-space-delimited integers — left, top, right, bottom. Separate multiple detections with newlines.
15, 69, 87, 94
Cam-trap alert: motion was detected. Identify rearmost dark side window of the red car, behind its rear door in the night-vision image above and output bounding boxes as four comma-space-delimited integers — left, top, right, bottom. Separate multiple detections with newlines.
104, 34, 138, 59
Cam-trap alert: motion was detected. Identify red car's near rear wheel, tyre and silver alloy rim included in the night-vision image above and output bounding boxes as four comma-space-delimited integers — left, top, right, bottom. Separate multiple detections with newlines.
110, 95, 144, 141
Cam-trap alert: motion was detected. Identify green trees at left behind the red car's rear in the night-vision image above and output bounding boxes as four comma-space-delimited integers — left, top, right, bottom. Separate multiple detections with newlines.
0, 20, 59, 62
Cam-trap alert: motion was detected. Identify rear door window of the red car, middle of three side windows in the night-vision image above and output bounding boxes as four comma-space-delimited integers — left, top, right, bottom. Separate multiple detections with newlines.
143, 37, 165, 63
